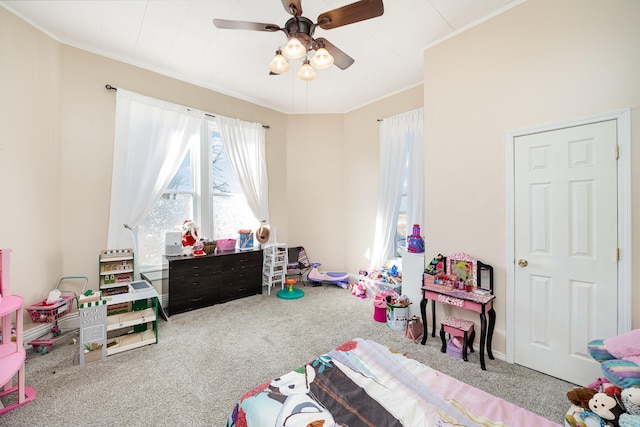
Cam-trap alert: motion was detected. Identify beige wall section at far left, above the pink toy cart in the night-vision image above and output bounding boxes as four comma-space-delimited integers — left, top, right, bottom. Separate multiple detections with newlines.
0, 7, 63, 302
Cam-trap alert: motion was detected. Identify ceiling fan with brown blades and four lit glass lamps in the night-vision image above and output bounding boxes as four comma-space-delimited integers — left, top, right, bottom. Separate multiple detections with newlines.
213, 0, 384, 80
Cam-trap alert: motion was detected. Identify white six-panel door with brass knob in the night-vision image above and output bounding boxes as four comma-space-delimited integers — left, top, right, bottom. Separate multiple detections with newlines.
513, 120, 618, 386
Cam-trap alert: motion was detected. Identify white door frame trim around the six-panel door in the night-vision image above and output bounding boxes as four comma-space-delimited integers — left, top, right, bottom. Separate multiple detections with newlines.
505, 108, 633, 363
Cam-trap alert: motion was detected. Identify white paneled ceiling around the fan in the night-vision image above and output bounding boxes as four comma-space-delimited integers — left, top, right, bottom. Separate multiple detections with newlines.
0, 0, 524, 114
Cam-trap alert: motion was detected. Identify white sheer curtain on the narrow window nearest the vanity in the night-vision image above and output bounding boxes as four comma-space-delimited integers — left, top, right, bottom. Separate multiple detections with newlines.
370, 109, 424, 270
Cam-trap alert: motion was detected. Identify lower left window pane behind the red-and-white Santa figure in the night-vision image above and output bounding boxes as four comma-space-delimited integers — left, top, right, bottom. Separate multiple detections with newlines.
136, 193, 193, 269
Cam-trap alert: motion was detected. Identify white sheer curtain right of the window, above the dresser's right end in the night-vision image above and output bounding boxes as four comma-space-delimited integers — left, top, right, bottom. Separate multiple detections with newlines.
216, 116, 269, 223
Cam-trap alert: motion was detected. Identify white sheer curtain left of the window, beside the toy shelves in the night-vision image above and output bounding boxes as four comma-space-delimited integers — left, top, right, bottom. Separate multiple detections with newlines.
107, 89, 204, 253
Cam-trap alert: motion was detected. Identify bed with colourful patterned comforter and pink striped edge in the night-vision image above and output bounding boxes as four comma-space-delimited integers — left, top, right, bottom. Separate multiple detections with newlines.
227, 338, 558, 427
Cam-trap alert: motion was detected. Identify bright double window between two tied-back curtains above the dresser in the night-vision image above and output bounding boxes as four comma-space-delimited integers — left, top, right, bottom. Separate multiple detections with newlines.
136, 122, 259, 271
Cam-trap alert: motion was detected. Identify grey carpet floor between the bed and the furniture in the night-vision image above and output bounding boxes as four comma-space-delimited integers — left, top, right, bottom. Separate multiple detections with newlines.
0, 285, 573, 427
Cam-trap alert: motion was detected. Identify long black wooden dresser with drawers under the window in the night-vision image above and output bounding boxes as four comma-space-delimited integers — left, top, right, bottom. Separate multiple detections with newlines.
167, 250, 262, 316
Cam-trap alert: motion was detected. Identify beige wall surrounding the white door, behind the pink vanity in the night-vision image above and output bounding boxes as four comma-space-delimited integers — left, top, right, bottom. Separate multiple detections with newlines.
424, 0, 640, 352
